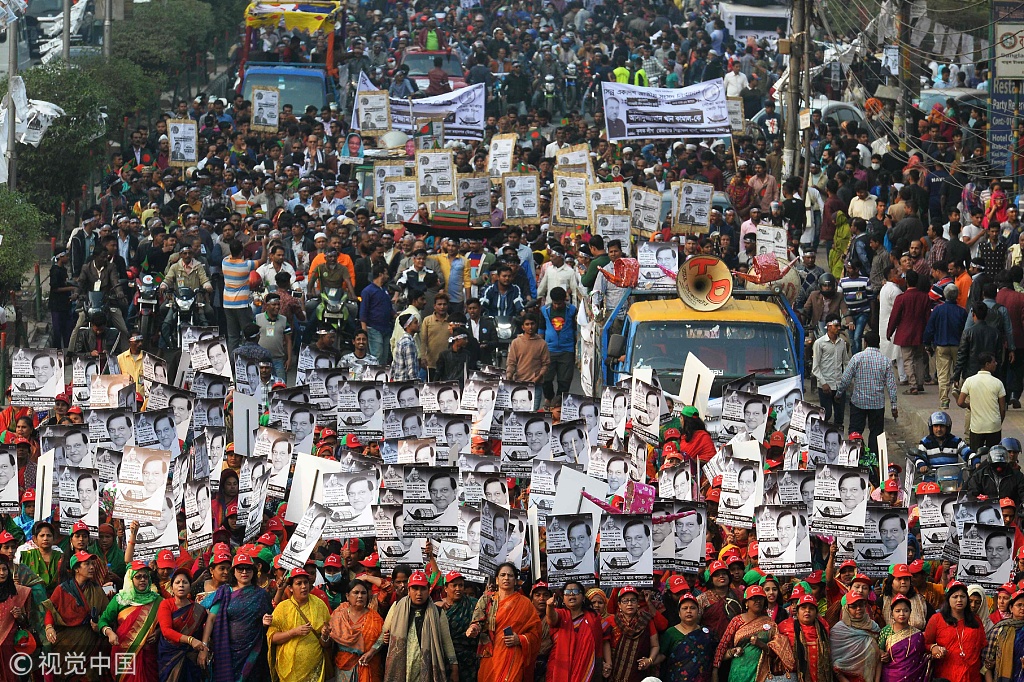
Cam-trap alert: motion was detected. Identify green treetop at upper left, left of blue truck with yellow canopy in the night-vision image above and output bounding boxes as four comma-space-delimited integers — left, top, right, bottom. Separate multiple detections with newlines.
112, 0, 214, 88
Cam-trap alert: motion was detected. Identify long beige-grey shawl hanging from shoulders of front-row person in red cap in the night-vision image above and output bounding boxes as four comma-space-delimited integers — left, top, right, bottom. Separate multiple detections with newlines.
381, 597, 456, 682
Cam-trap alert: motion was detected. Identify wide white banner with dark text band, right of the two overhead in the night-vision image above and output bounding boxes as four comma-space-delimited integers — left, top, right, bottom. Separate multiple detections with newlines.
602, 79, 732, 142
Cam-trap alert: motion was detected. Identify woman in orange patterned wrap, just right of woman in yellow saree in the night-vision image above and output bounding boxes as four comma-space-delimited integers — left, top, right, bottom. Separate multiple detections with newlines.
330, 580, 384, 682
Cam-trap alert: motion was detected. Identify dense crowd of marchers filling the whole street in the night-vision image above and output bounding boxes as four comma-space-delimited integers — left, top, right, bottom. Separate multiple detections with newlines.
0, 0, 1024, 682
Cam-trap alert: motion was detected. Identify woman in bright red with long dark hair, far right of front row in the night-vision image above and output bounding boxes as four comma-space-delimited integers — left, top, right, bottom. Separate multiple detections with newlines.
925, 581, 985, 682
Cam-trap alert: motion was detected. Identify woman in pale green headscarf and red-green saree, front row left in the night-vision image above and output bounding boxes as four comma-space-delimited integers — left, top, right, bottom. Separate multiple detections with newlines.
99, 561, 161, 682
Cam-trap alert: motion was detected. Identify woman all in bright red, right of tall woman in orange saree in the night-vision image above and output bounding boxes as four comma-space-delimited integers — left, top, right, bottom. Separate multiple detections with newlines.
547, 582, 604, 682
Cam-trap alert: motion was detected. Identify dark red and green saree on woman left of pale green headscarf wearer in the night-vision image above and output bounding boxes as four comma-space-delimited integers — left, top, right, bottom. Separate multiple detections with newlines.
48, 580, 110, 682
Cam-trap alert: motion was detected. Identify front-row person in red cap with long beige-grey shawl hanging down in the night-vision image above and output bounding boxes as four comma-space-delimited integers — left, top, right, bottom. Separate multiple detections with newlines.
370, 570, 459, 682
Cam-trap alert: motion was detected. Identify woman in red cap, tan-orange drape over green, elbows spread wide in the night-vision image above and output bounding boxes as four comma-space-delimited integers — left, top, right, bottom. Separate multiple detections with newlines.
711, 585, 796, 682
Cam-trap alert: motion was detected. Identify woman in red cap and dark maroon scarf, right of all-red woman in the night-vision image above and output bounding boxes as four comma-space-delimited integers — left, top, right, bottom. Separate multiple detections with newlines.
602, 586, 660, 682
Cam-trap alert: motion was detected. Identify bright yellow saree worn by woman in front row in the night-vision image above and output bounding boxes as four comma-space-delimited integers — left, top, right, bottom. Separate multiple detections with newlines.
266, 595, 331, 682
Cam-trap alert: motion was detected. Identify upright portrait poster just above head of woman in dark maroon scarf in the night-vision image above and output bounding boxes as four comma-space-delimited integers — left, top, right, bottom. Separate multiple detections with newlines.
600, 512, 654, 588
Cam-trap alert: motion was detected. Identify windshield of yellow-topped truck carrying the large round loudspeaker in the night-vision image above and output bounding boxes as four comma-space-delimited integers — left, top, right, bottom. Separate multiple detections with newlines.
631, 321, 797, 393
